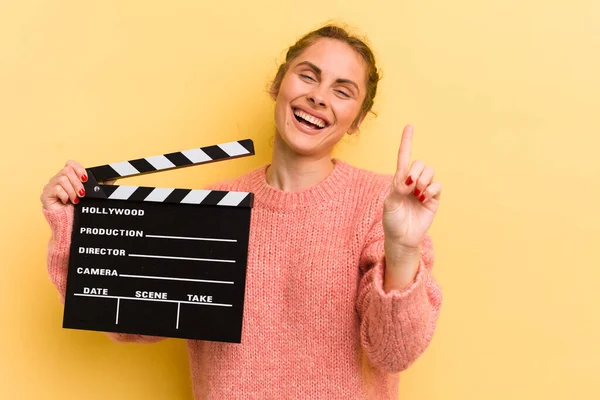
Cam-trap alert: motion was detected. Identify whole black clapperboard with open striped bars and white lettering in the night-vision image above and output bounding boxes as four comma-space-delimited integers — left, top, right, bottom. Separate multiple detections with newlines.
63, 139, 254, 343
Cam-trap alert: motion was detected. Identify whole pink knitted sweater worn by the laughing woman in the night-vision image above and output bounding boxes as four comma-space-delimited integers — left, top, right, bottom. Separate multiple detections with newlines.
44, 159, 442, 400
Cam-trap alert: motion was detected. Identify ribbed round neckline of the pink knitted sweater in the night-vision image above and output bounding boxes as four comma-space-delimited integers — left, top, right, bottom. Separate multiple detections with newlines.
250, 158, 352, 211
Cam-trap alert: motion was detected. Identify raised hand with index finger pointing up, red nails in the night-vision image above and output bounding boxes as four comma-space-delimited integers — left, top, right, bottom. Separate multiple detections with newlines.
383, 125, 442, 250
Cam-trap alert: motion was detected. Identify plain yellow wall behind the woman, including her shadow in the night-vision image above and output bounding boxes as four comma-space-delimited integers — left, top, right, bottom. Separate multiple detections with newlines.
0, 0, 600, 400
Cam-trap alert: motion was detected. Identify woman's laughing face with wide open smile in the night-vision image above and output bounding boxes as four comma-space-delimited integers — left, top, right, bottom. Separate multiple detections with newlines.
275, 38, 366, 157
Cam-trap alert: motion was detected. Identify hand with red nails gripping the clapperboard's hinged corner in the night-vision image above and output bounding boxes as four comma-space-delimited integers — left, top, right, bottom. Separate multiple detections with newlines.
40, 161, 87, 211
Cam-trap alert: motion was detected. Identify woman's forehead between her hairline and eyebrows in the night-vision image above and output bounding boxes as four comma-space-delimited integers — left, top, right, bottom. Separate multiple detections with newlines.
293, 38, 366, 86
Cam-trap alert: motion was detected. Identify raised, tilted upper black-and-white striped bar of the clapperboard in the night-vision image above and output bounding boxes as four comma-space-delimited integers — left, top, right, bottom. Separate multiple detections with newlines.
89, 139, 254, 182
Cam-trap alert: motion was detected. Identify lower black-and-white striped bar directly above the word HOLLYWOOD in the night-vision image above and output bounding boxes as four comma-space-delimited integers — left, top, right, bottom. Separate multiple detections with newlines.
95, 185, 254, 207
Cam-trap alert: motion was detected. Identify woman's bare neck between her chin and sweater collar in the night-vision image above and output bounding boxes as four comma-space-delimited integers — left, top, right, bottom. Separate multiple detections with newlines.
266, 134, 334, 192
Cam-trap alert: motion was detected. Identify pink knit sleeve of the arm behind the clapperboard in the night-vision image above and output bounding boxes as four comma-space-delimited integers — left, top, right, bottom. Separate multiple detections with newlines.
42, 205, 165, 343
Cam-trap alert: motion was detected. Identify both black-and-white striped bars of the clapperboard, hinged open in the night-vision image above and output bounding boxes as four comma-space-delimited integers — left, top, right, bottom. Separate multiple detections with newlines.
84, 139, 254, 207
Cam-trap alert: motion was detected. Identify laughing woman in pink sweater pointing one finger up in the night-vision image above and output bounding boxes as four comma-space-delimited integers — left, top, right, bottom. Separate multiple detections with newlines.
41, 26, 441, 399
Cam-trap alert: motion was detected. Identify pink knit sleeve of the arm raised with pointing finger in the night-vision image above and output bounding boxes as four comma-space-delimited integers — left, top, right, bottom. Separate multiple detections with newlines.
356, 192, 442, 373
